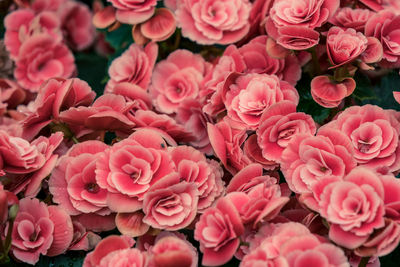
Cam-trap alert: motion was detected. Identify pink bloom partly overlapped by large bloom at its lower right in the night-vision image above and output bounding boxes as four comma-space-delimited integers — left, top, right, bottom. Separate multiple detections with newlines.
281, 129, 356, 193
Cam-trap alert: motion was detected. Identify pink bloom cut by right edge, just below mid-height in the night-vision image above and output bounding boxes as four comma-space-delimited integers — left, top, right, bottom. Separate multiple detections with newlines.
327, 105, 400, 172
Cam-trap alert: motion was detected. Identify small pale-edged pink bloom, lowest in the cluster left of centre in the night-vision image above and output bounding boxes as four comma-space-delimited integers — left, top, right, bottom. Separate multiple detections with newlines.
143, 173, 199, 231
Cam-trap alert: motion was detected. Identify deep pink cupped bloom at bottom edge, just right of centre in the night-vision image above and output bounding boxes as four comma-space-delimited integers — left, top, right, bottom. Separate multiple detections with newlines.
194, 198, 244, 266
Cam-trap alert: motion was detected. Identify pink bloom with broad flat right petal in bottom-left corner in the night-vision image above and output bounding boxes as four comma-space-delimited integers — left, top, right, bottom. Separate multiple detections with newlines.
11, 198, 72, 264
